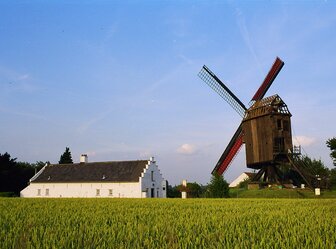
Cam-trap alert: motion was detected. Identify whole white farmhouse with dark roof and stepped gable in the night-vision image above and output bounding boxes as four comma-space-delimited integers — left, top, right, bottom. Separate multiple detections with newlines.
20, 155, 167, 198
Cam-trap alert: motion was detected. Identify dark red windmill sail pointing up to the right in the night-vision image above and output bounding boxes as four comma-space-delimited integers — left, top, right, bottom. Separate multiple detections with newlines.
252, 57, 285, 101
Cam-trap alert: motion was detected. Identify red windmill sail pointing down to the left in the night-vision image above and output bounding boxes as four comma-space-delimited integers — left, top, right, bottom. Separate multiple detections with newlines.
212, 125, 243, 175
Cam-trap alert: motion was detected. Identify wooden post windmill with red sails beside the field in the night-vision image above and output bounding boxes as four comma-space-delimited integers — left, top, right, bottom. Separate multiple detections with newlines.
198, 57, 312, 186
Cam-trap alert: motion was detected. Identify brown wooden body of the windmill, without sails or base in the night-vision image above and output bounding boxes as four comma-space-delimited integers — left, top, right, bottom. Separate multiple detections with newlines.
242, 95, 293, 169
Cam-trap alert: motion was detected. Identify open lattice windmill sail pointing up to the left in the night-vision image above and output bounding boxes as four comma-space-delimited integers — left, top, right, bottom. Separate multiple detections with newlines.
198, 65, 246, 117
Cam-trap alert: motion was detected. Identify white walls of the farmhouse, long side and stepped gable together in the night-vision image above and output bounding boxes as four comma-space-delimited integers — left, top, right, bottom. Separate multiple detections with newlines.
20, 158, 167, 198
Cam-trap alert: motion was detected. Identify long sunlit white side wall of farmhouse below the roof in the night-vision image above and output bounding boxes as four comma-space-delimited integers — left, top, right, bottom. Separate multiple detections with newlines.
20, 182, 141, 198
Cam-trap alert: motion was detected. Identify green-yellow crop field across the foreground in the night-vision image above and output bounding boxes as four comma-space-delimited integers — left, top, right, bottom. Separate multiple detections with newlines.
0, 198, 336, 249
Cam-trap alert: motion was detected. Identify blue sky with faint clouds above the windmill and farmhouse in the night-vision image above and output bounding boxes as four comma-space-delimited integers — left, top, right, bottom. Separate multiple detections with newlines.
0, 1, 336, 184
